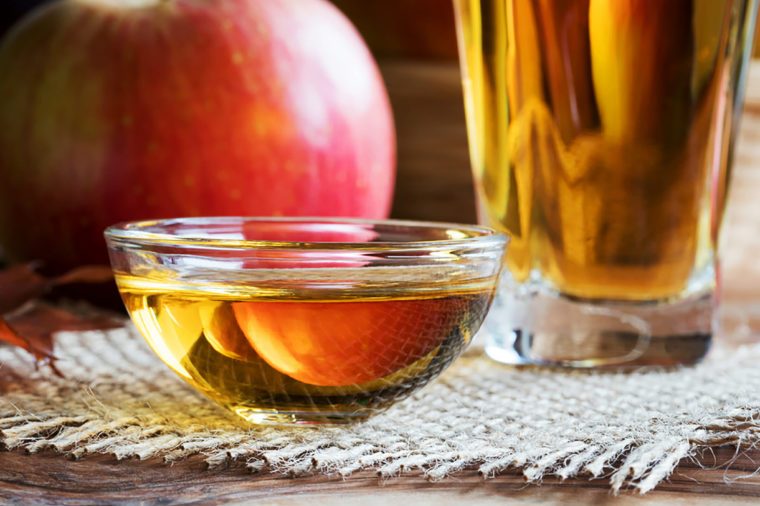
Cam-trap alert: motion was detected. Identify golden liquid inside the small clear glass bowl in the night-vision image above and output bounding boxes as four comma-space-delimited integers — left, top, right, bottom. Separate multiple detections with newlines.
117, 275, 493, 421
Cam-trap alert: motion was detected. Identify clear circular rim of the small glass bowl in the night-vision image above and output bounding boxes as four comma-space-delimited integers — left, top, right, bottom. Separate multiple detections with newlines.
104, 216, 509, 251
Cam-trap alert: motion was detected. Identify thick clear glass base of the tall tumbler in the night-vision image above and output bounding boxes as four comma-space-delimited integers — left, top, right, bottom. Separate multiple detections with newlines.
485, 280, 715, 368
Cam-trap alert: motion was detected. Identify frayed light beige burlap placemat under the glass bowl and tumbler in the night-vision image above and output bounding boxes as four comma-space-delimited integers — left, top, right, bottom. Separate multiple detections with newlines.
0, 320, 760, 492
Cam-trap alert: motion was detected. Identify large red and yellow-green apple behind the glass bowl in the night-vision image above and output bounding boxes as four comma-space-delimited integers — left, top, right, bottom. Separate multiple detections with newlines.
0, 0, 395, 271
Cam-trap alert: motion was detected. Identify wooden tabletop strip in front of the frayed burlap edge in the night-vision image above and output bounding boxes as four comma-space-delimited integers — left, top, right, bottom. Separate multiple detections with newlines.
0, 448, 760, 506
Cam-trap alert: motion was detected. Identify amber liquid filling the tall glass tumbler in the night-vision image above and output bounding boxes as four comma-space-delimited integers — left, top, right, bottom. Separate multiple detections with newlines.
454, 0, 754, 300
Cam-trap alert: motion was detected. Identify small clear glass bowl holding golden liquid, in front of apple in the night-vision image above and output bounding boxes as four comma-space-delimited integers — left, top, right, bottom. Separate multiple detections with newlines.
105, 217, 506, 424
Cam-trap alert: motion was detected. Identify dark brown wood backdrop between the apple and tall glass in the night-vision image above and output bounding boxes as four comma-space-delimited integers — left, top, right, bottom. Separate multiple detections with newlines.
382, 62, 476, 223
